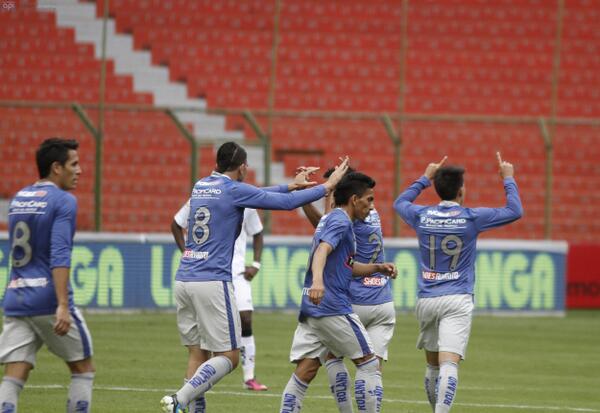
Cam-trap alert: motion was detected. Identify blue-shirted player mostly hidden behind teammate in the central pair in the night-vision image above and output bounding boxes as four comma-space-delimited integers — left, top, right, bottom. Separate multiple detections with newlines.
302, 168, 396, 413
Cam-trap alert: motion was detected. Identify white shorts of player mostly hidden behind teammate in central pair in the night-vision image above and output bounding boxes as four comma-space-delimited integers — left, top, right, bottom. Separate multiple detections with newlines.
352, 301, 396, 361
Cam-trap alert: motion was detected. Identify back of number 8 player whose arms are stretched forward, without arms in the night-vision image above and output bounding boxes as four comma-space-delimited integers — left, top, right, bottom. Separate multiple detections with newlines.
176, 173, 244, 281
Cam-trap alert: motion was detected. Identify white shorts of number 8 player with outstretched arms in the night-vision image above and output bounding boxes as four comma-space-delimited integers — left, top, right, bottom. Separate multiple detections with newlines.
175, 281, 242, 352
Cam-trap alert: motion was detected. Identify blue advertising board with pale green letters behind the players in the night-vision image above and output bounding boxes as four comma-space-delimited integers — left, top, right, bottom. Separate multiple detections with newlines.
0, 233, 567, 313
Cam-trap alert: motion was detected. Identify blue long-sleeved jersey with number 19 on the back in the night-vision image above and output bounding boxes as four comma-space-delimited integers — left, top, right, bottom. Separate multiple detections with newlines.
394, 176, 523, 297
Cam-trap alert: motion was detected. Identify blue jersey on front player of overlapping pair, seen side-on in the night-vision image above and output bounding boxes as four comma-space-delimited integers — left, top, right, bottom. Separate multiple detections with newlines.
300, 208, 356, 320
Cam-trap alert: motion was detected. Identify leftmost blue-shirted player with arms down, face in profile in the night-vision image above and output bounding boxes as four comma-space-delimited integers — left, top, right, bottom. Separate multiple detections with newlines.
0, 138, 95, 413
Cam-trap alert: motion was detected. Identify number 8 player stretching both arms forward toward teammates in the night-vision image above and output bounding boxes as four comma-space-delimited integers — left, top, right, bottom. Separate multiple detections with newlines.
161, 142, 348, 412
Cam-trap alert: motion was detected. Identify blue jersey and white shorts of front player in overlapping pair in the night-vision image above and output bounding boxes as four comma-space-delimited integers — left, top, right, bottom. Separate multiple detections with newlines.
290, 208, 373, 362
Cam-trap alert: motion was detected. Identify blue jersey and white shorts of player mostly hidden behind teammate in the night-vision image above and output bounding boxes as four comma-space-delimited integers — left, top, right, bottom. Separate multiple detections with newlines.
350, 210, 396, 360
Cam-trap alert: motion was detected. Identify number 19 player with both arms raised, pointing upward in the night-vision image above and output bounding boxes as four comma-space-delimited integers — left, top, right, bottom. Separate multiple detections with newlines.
394, 153, 523, 413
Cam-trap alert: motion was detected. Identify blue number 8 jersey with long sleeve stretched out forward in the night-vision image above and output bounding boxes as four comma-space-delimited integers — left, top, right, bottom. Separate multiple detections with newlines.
175, 172, 325, 281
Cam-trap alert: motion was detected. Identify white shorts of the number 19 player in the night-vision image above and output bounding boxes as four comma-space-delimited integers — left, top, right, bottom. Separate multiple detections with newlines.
415, 294, 475, 359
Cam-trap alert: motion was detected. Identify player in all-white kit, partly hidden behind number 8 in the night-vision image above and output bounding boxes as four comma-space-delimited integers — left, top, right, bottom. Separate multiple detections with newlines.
171, 208, 268, 391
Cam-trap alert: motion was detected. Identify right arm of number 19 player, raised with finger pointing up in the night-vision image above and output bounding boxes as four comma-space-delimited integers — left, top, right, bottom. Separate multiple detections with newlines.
472, 152, 523, 231
